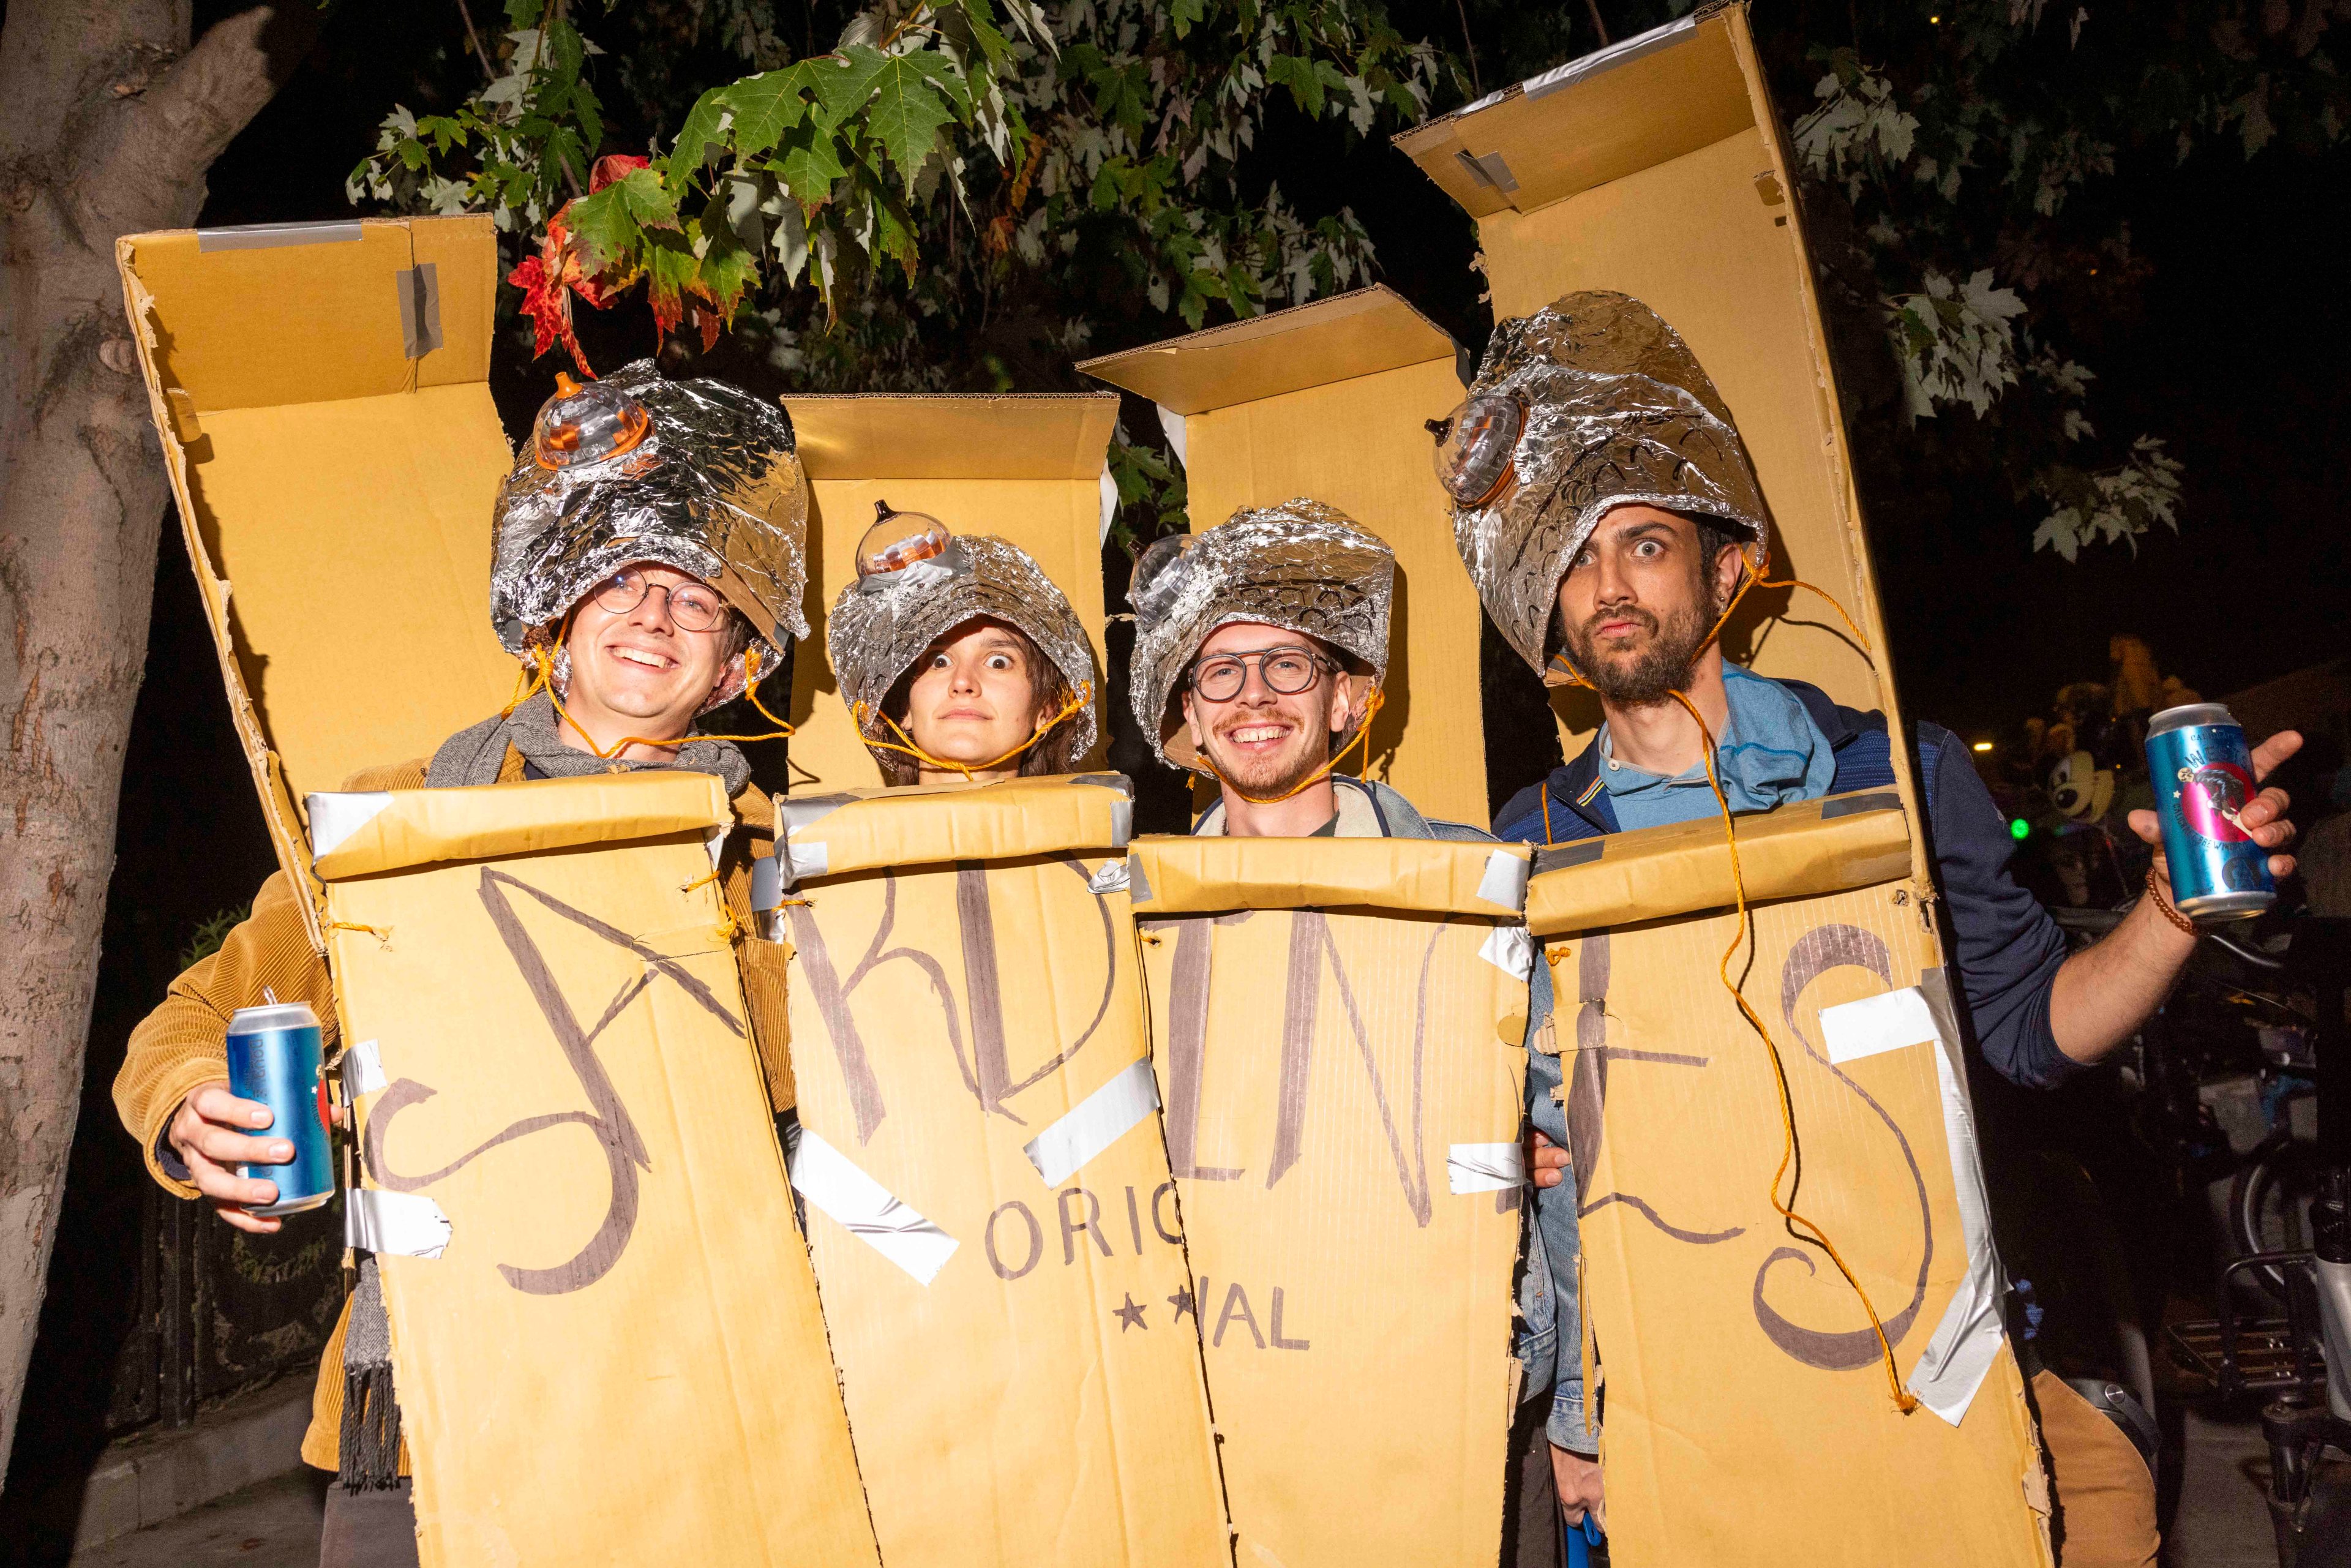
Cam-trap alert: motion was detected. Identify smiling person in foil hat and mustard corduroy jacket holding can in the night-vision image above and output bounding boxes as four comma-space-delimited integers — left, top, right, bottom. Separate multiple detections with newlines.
115, 359, 809, 1568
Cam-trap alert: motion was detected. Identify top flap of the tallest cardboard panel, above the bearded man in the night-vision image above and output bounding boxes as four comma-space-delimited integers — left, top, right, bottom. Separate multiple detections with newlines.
1397, 17, 1754, 219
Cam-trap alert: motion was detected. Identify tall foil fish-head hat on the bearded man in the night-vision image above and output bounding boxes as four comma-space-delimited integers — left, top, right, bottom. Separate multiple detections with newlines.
1430, 291, 1771, 684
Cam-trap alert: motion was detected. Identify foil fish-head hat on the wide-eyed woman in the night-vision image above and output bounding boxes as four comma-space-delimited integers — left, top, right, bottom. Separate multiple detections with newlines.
825, 501, 1103, 771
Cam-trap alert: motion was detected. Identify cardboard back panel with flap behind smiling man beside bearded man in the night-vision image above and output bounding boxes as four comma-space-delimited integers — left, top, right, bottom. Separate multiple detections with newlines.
1079, 287, 1486, 823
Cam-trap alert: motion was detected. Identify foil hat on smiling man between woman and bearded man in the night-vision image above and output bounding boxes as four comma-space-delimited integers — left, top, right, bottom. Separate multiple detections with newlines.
1128, 498, 1397, 769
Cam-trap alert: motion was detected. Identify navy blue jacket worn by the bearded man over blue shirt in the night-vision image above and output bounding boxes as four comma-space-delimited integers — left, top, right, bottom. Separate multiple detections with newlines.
1493, 681, 2080, 1089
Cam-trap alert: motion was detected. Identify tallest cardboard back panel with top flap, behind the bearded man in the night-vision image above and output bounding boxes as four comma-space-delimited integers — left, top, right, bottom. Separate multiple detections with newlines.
1399, 5, 1902, 808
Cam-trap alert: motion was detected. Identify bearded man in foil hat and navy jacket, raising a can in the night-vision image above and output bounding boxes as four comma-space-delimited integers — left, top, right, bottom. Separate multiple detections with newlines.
1434, 294, 2301, 1568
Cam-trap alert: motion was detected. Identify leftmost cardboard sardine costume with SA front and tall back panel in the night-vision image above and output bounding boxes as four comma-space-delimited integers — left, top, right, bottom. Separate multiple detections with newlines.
118, 219, 877, 1568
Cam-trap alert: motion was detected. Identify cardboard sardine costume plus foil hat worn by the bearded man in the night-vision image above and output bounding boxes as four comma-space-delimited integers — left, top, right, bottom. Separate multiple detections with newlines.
1399, 5, 2050, 1568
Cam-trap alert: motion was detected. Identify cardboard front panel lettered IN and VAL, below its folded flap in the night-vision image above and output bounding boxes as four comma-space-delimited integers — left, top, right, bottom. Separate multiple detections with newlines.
1138, 839, 1526, 1568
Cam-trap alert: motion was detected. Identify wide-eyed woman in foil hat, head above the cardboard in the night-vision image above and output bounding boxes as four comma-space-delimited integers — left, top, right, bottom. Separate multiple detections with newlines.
825, 501, 1095, 785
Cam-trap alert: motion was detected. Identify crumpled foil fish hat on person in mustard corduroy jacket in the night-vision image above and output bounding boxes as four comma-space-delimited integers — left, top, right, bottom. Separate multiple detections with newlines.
489, 359, 809, 708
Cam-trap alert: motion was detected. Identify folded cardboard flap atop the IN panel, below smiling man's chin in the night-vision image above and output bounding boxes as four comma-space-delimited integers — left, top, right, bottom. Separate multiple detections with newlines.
1126, 835, 1528, 919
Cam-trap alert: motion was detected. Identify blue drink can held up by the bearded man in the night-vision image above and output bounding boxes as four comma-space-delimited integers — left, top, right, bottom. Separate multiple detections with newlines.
2147, 703, 2278, 919
